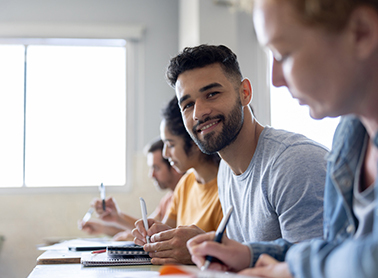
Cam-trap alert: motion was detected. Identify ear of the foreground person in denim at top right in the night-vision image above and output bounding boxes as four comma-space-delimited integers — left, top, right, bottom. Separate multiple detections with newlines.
349, 6, 378, 60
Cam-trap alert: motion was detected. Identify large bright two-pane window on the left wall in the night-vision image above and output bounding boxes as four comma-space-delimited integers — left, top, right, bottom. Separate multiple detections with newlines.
0, 39, 126, 187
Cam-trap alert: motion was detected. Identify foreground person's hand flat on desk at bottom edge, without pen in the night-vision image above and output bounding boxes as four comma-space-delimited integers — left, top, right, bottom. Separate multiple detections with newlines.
238, 254, 293, 278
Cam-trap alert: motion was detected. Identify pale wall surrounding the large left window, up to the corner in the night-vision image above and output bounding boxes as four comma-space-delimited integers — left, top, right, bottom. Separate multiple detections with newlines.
0, 0, 178, 278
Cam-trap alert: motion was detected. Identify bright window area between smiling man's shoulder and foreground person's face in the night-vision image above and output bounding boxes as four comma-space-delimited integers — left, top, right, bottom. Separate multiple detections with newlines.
270, 55, 340, 149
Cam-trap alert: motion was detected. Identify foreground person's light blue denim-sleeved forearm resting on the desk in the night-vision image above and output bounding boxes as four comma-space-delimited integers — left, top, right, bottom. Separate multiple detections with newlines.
286, 234, 378, 278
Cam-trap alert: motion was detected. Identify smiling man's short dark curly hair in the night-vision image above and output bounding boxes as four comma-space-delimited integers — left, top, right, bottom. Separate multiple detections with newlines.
166, 44, 243, 88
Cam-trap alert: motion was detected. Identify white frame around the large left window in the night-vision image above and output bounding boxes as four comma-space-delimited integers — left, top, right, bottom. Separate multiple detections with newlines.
0, 23, 145, 194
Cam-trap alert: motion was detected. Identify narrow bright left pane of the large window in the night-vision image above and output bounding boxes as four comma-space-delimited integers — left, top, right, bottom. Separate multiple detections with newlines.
0, 45, 25, 187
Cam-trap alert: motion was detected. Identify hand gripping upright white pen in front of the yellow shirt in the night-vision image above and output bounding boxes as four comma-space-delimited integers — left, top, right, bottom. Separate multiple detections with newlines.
131, 218, 172, 245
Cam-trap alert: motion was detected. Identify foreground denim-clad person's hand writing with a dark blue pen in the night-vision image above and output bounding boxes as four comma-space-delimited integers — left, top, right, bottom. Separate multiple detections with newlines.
187, 232, 251, 271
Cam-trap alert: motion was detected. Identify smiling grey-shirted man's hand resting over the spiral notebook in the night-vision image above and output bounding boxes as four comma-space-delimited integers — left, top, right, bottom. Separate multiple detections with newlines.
144, 225, 205, 265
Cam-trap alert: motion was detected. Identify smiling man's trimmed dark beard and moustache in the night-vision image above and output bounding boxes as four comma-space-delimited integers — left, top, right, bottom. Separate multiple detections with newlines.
190, 99, 244, 155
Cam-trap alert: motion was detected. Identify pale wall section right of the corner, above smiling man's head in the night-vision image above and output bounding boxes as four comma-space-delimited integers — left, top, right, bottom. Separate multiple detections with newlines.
179, 0, 270, 125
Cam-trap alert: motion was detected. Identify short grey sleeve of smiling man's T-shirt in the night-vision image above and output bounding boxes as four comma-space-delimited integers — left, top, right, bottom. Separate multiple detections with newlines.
266, 144, 326, 242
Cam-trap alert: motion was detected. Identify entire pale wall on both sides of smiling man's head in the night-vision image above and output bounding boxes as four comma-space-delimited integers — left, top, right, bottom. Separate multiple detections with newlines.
0, 0, 269, 278
